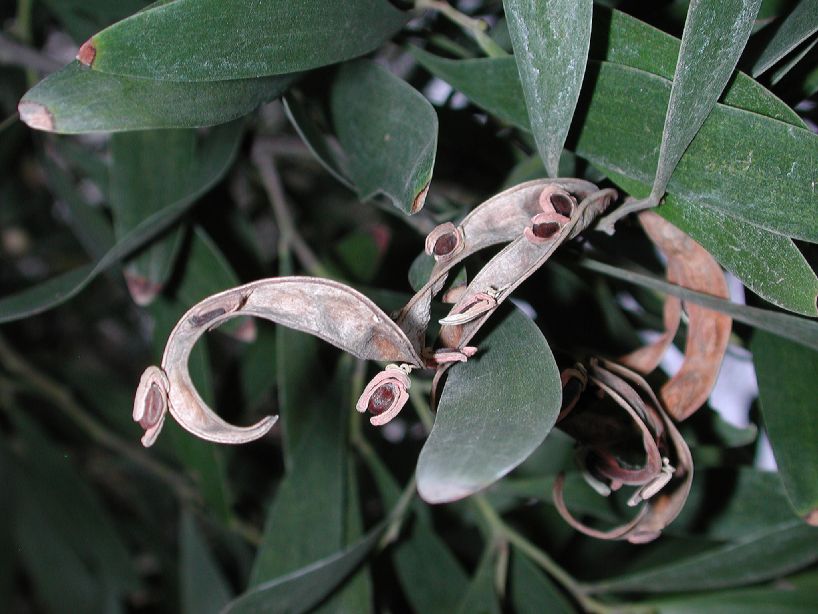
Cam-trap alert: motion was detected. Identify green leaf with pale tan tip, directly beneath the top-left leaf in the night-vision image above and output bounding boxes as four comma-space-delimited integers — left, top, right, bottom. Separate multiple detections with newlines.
20, 62, 298, 134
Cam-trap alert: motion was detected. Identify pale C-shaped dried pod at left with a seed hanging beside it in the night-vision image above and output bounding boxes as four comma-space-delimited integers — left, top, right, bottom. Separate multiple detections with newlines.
133, 277, 423, 446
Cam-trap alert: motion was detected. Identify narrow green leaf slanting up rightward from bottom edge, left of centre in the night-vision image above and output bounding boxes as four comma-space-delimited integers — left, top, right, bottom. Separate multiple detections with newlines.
222, 522, 387, 614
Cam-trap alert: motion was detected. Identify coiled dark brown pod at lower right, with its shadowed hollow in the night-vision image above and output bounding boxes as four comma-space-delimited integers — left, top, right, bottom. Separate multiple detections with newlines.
553, 359, 693, 543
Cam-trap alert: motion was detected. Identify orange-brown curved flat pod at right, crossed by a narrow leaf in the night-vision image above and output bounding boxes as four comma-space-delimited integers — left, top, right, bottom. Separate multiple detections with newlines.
620, 211, 732, 420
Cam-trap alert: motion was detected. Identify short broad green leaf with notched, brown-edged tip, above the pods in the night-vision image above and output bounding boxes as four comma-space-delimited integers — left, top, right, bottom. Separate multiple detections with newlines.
330, 60, 437, 214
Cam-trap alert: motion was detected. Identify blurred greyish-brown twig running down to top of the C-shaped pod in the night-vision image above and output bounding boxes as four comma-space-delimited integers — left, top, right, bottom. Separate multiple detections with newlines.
251, 143, 330, 277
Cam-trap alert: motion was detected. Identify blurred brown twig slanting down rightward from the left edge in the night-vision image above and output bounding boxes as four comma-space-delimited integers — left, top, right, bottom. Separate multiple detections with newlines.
0, 336, 198, 501
